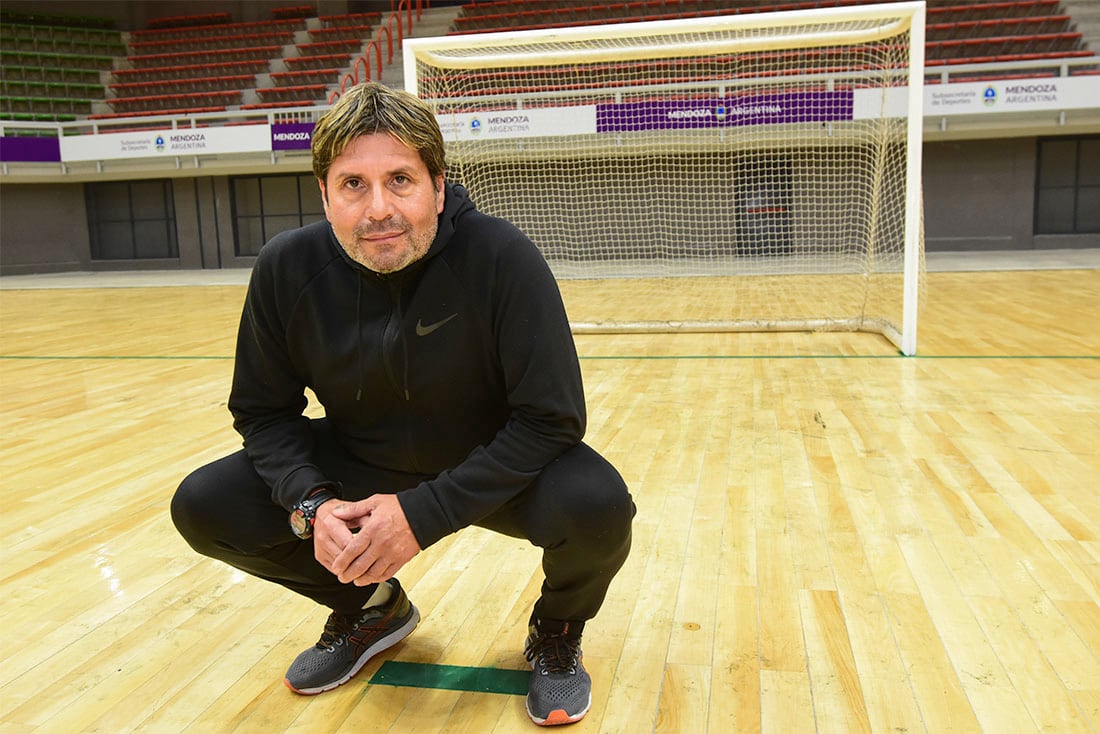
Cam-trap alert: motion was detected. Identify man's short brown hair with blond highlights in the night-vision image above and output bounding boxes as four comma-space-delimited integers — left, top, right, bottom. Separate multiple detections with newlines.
309, 81, 447, 183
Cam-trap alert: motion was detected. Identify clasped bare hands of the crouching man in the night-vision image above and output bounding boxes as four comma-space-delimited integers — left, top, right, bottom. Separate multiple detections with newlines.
314, 494, 420, 587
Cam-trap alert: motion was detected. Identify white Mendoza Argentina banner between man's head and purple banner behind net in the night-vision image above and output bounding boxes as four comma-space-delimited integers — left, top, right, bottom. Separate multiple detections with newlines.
436, 105, 596, 143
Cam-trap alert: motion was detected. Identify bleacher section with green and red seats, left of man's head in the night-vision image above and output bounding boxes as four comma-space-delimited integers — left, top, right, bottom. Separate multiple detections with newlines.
0, 6, 381, 122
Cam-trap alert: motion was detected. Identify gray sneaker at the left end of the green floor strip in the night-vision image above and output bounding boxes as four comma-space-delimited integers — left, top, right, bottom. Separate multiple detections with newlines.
284, 579, 420, 695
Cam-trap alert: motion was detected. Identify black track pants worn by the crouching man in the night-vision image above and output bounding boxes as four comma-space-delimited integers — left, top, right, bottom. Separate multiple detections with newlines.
172, 419, 635, 622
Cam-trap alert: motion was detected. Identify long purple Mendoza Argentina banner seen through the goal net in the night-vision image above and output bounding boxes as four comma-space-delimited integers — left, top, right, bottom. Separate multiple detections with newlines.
596, 89, 853, 132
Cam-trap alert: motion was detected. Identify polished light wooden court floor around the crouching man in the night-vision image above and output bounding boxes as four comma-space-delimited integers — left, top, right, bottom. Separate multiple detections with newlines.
0, 270, 1100, 734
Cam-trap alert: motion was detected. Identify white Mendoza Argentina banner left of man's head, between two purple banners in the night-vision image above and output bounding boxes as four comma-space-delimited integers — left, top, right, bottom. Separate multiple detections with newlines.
61, 124, 272, 161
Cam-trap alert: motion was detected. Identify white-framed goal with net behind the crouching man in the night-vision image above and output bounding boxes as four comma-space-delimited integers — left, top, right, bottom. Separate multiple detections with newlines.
405, 2, 924, 354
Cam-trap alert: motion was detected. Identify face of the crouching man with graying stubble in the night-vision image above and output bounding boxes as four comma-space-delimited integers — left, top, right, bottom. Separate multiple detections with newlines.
319, 133, 443, 273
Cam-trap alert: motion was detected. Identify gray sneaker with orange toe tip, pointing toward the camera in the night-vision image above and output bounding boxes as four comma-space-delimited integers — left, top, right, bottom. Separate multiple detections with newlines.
524, 624, 592, 726
